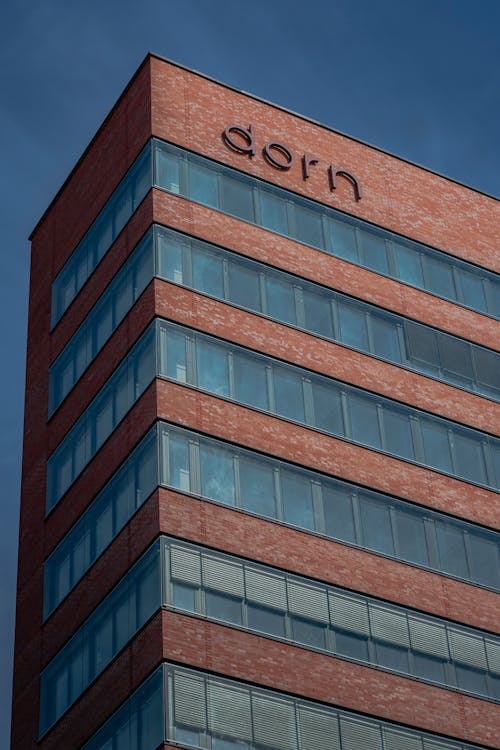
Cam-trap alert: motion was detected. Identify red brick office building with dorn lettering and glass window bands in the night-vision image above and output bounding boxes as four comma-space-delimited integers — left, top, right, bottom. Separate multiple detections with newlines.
12, 56, 500, 750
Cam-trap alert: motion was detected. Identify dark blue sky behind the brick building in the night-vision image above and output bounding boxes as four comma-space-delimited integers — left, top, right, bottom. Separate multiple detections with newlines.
0, 0, 500, 748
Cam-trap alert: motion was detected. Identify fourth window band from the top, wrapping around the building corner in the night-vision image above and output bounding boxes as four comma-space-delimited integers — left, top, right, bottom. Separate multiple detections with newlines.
44, 422, 500, 619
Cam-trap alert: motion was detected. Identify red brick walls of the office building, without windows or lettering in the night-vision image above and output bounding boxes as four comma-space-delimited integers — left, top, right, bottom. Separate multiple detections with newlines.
12, 57, 500, 750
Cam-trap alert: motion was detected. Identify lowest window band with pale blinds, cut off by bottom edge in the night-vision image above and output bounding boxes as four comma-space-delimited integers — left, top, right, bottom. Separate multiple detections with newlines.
82, 662, 492, 750
